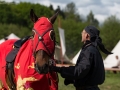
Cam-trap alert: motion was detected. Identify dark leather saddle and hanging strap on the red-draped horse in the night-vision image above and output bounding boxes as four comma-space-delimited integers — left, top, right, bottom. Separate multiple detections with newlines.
6, 36, 30, 90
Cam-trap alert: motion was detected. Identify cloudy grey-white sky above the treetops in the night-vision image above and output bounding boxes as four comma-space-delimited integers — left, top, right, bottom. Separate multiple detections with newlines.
5, 0, 120, 22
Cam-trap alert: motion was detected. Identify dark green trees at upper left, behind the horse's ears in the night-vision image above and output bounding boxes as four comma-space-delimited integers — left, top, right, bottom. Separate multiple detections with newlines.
0, 2, 52, 28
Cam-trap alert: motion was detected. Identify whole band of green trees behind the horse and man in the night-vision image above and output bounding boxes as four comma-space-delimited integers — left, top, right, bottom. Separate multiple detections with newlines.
0, 2, 120, 58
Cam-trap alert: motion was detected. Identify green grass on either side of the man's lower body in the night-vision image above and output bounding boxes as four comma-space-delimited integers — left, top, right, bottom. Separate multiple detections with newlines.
58, 71, 120, 90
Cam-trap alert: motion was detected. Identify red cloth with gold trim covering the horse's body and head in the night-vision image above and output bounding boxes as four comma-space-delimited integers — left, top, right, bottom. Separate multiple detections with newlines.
0, 17, 58, 90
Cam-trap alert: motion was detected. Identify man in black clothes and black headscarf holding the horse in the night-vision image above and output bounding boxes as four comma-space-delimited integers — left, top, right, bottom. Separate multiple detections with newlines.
52, 26, 112, 90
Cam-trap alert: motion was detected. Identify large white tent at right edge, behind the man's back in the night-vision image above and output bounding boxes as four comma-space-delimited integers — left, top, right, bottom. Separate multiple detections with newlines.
104, 41, 120, 68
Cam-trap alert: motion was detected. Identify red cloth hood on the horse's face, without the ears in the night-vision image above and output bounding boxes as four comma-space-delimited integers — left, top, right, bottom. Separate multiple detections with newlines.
33, 17, 55, 56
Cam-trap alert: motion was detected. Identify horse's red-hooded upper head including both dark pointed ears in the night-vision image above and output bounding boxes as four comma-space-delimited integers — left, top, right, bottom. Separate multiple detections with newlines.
30, 9, 59, 57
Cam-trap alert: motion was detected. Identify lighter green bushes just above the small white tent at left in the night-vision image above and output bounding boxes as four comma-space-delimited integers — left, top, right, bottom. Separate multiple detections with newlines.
0, 23, 31, 39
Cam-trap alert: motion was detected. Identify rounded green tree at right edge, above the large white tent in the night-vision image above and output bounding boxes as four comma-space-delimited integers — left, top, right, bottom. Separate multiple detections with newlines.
100, 16, 120, 56
